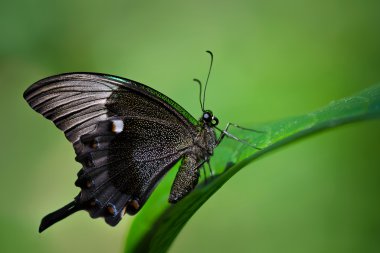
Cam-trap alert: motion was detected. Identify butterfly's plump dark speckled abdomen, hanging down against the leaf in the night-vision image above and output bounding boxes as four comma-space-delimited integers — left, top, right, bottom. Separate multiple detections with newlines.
169, 155, 205, 203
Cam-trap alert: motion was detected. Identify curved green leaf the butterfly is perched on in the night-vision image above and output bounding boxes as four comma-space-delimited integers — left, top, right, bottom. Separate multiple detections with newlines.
125, 85, 380, 253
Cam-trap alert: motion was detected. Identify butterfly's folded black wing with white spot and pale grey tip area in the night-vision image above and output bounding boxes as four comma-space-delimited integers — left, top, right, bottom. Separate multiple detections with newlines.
24, 73, 197, 226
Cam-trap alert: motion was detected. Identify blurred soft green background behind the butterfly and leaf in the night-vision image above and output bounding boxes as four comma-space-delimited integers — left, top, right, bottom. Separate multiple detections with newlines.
0, 0, 380, 253
